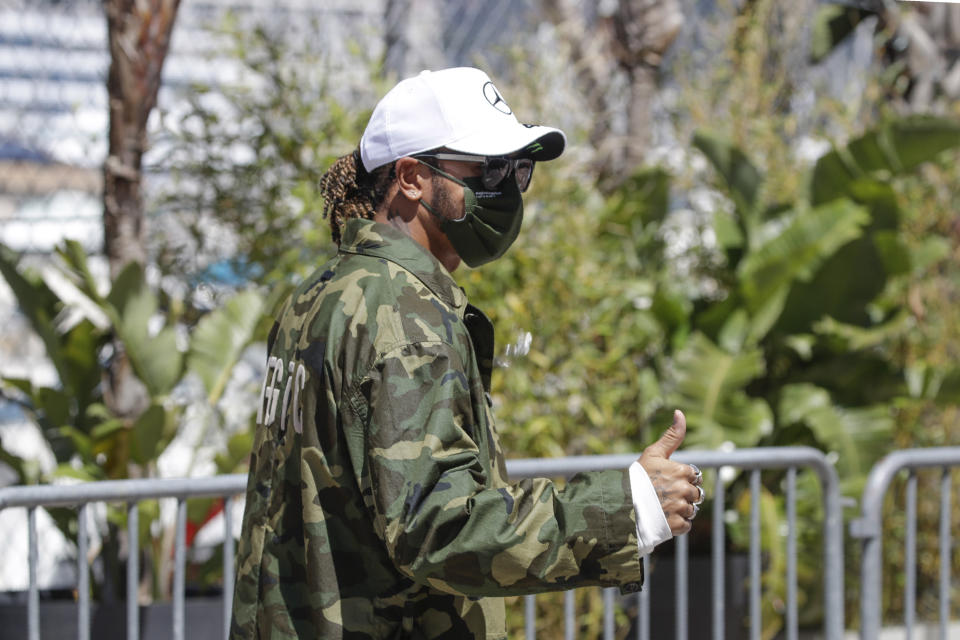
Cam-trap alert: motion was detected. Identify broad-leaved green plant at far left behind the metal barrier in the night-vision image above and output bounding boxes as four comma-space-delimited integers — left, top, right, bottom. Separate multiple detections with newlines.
0, 241, 283, 596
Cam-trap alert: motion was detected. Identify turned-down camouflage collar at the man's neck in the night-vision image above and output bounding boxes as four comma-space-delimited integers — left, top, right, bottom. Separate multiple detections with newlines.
340, 218, 467, 308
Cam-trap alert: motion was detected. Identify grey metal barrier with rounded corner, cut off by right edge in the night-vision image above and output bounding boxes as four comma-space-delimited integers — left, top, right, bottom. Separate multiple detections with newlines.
850, 447, 960, 640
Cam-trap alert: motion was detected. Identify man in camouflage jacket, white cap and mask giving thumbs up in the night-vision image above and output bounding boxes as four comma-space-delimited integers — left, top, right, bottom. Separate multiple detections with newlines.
231, 68, 703, 639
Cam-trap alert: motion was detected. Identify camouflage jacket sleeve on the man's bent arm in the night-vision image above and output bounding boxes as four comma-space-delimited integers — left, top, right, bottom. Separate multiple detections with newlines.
347, 342, 642, 596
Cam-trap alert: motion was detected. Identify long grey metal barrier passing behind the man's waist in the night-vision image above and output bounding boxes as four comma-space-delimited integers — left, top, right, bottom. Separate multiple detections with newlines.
0, 447, 844, 640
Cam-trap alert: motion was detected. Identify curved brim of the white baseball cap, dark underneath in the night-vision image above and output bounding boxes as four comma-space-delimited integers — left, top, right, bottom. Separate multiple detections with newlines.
444, 123, 567, 162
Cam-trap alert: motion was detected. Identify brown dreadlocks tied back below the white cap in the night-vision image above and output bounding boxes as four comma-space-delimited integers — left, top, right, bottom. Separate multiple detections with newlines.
320, 147, 396, 245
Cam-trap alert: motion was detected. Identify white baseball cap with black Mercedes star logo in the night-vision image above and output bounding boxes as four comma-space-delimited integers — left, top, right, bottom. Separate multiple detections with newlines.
360, 67, 567, 171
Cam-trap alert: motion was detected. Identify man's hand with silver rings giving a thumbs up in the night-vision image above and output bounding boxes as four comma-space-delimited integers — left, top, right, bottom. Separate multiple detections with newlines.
640, 410, 703, 536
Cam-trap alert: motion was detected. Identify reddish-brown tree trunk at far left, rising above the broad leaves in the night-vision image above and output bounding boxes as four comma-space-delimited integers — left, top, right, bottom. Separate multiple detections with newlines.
103, 0, 180, 277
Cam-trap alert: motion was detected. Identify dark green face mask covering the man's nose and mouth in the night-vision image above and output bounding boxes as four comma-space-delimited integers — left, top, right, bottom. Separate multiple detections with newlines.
420, 163, 523, 267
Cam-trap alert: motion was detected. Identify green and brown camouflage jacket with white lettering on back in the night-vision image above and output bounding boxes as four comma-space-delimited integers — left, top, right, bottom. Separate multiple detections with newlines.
231, 220, 642, 640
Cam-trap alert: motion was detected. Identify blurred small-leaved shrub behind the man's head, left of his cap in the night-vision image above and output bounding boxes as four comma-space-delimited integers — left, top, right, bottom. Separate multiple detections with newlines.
152, 15, 386, 287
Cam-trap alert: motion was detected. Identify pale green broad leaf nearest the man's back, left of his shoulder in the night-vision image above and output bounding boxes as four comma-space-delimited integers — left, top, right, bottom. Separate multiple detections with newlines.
187, 291, 264, 404
